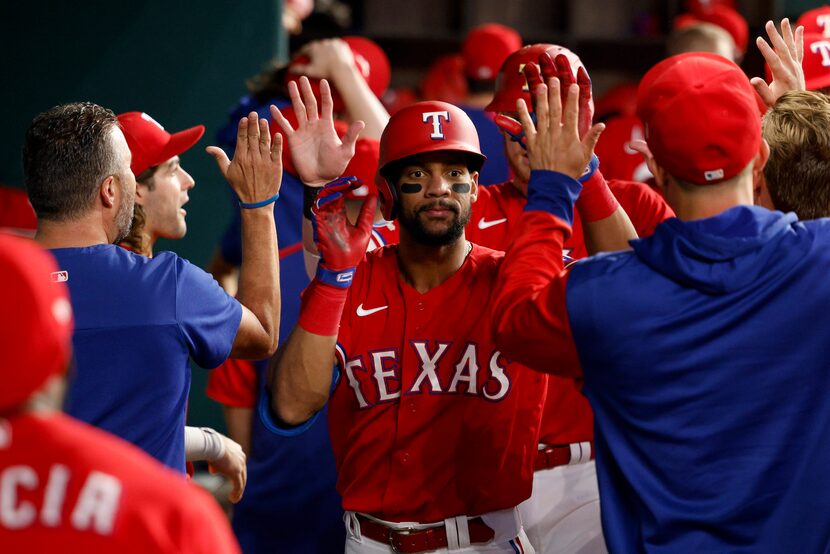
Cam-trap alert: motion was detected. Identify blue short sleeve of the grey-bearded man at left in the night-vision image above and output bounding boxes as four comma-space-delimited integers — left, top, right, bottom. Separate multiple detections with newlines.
176, 258, 242, 368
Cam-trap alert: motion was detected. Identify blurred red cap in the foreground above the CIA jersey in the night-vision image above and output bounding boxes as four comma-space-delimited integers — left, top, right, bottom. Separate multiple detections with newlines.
0, 233, 72, 412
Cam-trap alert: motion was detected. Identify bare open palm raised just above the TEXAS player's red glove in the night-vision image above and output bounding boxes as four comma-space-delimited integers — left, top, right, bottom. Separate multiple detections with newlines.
271, 77, 363, 187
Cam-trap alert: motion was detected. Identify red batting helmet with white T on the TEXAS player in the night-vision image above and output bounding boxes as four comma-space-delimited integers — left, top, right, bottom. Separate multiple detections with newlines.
375, 101, 487, 221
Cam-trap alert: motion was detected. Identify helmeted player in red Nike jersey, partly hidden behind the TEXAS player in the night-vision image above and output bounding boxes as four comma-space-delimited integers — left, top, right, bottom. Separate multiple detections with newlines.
466, 44, 673, 552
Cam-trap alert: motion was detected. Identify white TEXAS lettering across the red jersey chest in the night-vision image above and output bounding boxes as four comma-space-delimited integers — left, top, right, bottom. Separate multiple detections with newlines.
337, 340, 512, 409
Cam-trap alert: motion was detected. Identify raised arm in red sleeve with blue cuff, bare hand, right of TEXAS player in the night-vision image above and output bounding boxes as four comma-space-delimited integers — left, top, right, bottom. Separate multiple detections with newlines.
493, 78, 604, 376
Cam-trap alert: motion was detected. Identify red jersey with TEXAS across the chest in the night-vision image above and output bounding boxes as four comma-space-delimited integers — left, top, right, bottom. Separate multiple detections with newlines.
329, 245, 547, 522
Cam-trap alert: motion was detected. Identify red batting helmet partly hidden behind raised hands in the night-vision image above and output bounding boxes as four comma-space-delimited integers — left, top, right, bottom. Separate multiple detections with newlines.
484, 44, 587, 112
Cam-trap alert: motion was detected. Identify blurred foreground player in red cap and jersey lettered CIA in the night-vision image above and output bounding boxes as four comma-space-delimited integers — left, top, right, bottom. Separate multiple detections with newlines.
0, 234, 239, 554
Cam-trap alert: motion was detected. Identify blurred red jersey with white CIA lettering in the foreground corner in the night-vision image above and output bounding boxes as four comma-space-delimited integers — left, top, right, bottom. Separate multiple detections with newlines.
0, 413, 239, 554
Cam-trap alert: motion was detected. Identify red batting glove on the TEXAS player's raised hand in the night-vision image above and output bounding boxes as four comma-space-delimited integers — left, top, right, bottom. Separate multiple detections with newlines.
311, 177, 377, 288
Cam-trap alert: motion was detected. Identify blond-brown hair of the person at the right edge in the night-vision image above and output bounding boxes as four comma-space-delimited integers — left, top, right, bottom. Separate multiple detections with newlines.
762, 91, 830, 219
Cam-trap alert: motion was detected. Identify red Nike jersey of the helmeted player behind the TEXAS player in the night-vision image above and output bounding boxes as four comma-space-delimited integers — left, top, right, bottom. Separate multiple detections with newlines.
465, 180, 674, 444
